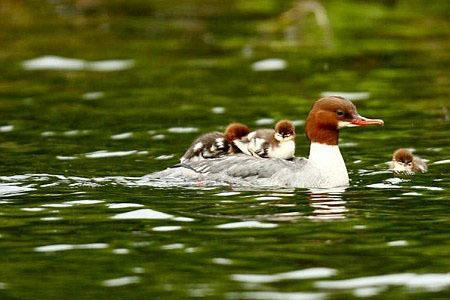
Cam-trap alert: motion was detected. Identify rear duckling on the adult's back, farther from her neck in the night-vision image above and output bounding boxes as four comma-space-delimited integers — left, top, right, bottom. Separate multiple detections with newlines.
180, 123, 250, 163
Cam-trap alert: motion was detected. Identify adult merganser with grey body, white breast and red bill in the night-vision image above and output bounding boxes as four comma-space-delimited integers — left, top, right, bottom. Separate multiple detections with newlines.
152, 97, 384, 188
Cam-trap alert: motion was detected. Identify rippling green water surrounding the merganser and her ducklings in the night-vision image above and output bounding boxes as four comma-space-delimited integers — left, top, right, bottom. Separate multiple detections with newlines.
0, 0, 450, 299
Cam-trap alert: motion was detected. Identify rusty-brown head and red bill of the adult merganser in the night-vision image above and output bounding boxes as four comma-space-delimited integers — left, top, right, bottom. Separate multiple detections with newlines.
305, 96, 384, 145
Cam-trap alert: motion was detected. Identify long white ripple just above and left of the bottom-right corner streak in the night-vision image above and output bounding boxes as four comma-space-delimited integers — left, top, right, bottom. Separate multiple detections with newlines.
231, 268, 337, 283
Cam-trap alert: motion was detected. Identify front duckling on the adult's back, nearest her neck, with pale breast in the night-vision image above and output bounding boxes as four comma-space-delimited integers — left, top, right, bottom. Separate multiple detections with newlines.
234, 120, 295, 159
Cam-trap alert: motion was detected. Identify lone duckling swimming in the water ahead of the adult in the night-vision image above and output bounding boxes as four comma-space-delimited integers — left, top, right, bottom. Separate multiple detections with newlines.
389, 148, 428, 174
